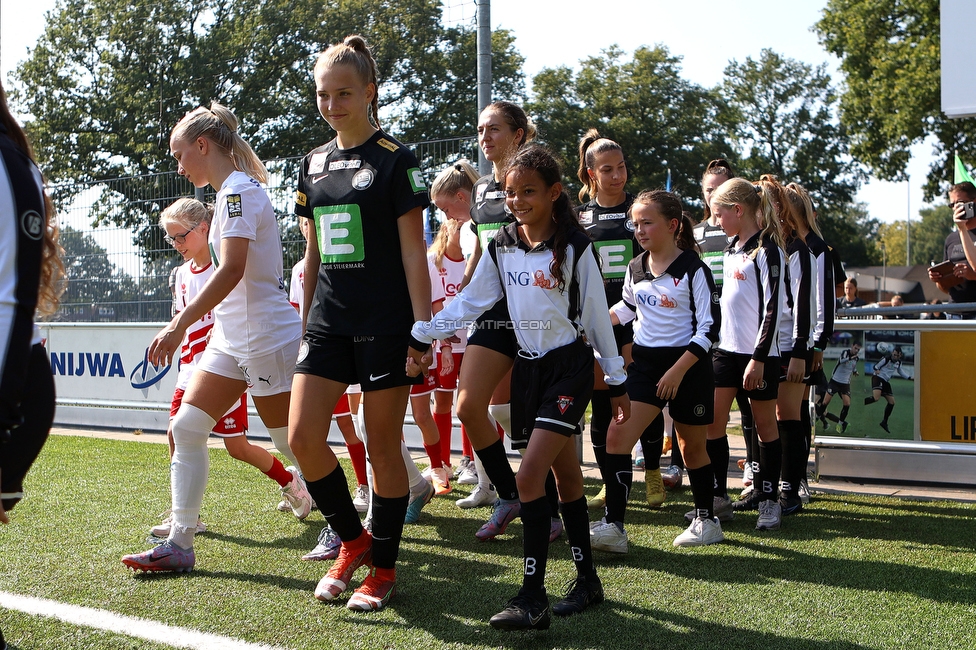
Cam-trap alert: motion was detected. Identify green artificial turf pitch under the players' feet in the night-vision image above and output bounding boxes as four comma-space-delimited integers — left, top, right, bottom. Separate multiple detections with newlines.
0, 436, 976, 650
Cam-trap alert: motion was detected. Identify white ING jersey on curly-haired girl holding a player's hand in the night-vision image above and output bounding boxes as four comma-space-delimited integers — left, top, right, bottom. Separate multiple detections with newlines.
413, 223, 627, 386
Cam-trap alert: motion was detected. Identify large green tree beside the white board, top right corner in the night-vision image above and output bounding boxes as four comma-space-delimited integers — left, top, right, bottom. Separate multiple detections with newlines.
814, 0, 976, 201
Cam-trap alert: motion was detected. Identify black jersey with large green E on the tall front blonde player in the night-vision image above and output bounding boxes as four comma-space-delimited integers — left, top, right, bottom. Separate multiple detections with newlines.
295, 131, 430, 336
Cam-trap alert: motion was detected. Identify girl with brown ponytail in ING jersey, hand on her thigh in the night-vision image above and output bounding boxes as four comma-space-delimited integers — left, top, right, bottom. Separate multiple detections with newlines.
590, 190, 725, 553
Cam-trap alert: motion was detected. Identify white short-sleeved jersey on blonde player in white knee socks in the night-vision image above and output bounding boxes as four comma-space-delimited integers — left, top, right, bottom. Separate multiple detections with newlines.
210, 172, 302, 359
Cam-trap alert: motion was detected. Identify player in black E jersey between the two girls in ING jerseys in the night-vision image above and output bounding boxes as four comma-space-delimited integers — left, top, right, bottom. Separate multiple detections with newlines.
576, 129, 665, 508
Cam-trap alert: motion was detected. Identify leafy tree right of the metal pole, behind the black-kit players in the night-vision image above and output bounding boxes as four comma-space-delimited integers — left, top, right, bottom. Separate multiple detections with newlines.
527, 45, 732, 203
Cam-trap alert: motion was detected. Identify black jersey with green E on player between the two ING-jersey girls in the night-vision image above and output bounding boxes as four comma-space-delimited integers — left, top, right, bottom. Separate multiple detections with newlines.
576, 193, 641, 305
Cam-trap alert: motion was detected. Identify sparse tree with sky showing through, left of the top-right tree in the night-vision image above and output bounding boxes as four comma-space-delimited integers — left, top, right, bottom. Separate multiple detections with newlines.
721, 49, 864, 220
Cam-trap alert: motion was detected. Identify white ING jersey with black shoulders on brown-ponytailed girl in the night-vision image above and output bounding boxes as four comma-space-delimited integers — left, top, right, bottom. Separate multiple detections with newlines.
611, 250, 722, 358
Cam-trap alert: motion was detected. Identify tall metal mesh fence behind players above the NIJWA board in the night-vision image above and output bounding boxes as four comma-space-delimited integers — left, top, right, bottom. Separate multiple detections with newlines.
49, 137, 478, 322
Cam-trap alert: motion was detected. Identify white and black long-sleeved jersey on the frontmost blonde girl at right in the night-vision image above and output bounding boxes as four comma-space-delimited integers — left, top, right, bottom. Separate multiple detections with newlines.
719, 233, 784, 363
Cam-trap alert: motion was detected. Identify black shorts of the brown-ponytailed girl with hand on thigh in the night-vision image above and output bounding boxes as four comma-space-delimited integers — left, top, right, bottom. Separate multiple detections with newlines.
627, 345, 715, 425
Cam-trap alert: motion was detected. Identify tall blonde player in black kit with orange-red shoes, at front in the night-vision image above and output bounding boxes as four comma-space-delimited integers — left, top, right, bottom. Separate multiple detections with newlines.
289, 36, 431, 611
